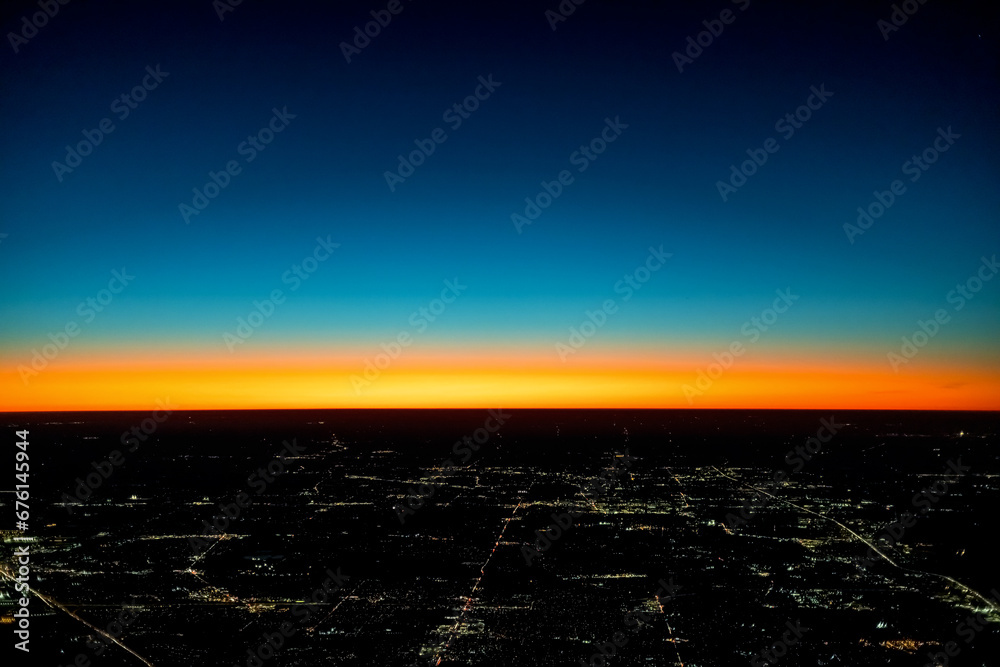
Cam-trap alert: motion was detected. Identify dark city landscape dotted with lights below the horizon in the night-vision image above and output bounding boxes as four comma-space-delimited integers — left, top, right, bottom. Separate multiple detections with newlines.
0, 410, 1000, 667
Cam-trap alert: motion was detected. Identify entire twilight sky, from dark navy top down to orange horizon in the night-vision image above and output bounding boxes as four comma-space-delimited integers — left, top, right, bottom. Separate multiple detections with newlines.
0, 0, 1000, 411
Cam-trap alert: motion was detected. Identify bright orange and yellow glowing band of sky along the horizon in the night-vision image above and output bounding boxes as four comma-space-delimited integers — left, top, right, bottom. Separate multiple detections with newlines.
0, 352, 1000, 412
